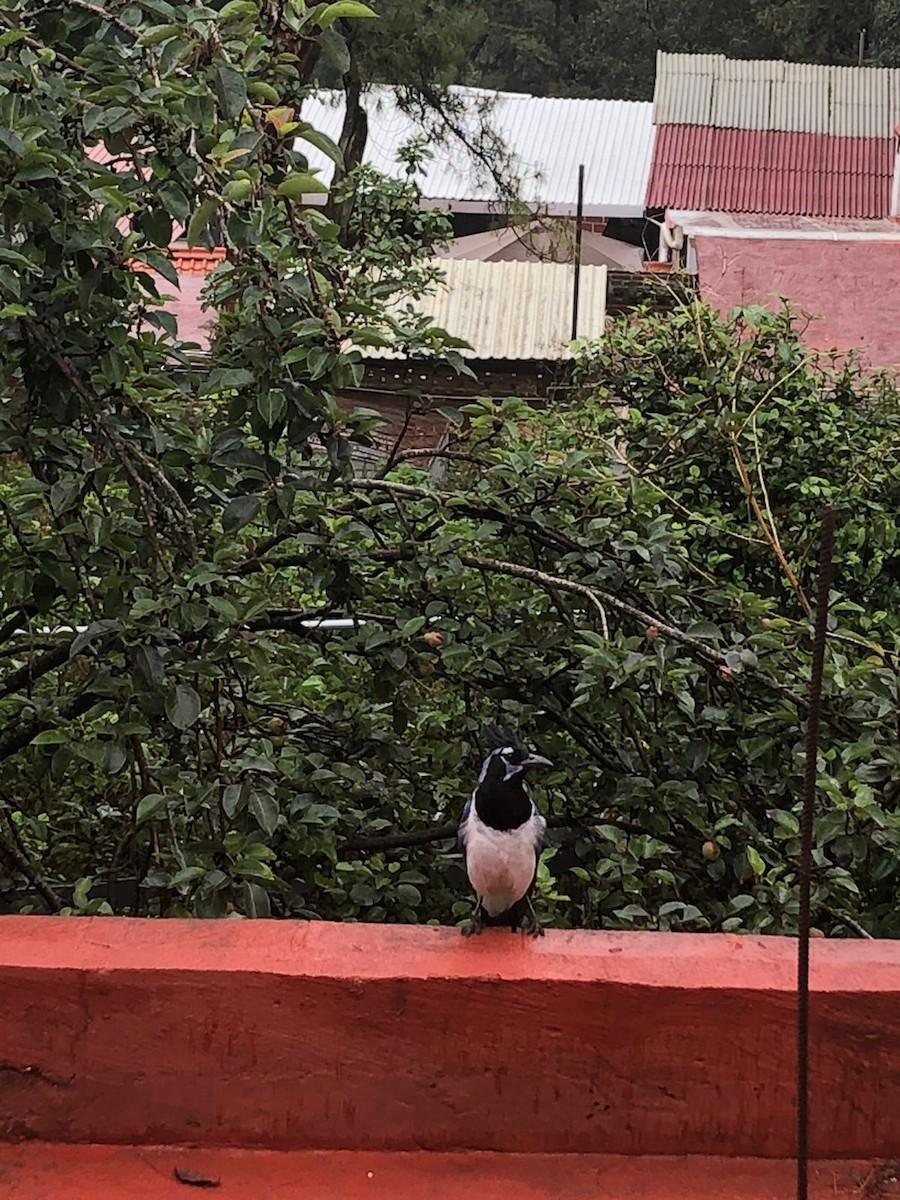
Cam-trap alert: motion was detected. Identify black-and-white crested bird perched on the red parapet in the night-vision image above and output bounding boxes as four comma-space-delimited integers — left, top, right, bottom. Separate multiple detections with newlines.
460, 727, 552, 937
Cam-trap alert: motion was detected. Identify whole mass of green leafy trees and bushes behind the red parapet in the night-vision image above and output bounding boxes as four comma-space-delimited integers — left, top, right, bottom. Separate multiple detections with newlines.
0, 0, 900, 935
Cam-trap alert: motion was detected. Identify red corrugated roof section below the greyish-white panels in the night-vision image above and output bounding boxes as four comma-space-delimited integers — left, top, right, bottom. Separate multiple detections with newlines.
647, 125, 894, 220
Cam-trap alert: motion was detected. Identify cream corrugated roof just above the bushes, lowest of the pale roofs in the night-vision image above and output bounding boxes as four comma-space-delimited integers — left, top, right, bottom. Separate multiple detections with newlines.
364, 258, 606, 361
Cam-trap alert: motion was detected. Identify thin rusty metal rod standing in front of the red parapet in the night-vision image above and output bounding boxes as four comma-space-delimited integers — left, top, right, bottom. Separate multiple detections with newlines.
797, 505, 834, 1200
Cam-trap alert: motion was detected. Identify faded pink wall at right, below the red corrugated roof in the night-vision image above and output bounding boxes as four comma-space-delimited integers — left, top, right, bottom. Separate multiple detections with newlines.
697, 236, 900, 367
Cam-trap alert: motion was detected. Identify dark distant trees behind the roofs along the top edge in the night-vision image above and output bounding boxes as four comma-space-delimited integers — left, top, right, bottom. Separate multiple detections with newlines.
338, 0, 900, 100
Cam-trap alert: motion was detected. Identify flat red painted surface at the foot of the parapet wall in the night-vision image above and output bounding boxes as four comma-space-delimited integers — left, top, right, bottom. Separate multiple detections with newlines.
0, 1142, 893, 1200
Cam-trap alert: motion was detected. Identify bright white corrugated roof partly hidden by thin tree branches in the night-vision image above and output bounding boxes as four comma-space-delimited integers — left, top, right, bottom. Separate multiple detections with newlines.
298, 86, 653, 217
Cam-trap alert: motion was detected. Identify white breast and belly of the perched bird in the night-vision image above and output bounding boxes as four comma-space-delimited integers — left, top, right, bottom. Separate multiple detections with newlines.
466, 804, 546, 917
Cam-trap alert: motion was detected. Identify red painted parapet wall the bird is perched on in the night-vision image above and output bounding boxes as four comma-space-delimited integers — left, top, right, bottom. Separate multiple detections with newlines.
0, 917, 900, 1161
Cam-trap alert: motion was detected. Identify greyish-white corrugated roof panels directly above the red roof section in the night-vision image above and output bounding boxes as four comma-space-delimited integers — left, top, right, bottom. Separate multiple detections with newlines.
653, 52, 900, 138
